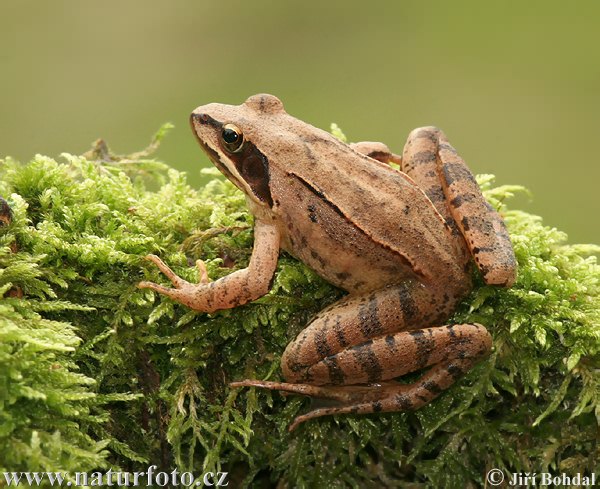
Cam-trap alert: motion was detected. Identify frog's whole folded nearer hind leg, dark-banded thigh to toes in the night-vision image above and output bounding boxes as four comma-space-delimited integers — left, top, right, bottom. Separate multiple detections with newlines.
231, 283, 492, 430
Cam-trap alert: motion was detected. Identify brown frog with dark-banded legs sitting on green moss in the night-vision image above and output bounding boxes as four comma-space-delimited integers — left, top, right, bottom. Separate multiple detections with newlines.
138, 94, 517, 430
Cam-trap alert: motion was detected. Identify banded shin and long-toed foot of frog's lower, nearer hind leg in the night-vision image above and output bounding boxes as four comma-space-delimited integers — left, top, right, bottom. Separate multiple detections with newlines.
232, 324, 491, 431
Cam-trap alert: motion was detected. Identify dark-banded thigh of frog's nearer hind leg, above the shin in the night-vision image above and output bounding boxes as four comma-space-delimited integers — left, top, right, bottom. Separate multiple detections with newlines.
281, 282, 454, 384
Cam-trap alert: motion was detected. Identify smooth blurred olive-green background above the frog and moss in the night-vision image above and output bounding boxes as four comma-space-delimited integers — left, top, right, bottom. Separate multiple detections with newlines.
0, 0, 600, 242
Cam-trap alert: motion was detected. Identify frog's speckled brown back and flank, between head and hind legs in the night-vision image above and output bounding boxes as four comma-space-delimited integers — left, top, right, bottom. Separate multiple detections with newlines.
272, 125, 468, 292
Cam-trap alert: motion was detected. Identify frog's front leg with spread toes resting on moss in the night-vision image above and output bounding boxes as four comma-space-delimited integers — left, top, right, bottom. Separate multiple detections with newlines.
138, 220, 280, 312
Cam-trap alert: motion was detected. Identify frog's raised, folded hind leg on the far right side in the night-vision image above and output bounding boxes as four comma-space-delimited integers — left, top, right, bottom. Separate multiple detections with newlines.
401, 127, 516, 287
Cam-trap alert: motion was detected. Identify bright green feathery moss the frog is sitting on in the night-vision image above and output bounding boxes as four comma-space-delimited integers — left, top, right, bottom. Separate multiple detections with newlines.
0, 127, 600, 487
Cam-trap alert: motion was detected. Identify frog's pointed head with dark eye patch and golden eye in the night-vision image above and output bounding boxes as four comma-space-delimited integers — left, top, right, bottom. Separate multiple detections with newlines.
190, 94, 285, 207
